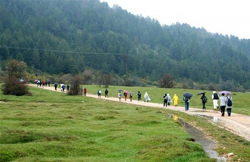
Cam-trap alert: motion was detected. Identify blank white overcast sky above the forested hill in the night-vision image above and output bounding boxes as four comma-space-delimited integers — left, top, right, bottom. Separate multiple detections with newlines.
100, 0, 250, 39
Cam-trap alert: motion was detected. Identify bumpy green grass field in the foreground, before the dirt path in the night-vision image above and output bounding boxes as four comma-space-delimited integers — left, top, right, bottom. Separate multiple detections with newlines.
0, 86, 250, 162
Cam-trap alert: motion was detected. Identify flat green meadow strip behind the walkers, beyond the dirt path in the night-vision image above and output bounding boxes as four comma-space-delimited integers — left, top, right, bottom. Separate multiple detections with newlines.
82, 85, 250, 115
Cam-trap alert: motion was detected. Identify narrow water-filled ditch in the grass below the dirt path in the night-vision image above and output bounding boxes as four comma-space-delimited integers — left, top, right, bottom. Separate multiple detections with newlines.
169, 114, 227, 162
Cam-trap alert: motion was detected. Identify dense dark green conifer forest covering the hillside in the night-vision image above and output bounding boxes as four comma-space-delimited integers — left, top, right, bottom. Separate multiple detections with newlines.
0, 0, 250, 88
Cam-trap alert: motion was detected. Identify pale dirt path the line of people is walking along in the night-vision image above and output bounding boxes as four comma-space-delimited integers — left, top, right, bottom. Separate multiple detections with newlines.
31, 85, 250, 141
